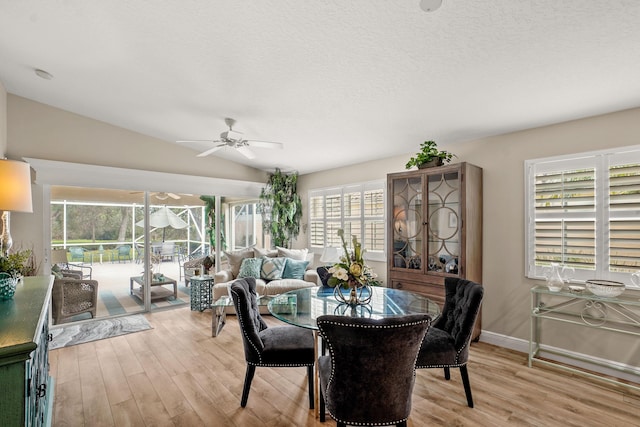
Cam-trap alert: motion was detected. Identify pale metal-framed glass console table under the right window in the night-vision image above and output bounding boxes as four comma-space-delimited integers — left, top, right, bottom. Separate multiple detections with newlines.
529, 286, 640, 390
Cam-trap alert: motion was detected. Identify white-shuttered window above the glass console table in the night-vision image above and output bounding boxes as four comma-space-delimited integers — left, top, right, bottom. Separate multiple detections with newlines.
525, 146, 640, 283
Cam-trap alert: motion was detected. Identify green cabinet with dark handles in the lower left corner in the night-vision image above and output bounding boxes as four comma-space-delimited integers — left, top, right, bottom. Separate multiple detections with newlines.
0, 276, 53, 426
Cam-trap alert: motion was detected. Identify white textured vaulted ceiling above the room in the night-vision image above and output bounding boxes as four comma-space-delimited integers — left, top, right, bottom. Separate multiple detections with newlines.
0, 0, 640, 174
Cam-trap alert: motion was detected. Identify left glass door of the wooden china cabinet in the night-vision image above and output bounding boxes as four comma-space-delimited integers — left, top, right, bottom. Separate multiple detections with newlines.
393, 177, 424, 270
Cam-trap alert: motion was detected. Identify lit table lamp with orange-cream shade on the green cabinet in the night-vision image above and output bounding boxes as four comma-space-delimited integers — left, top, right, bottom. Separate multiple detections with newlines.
0, 159, 33, 256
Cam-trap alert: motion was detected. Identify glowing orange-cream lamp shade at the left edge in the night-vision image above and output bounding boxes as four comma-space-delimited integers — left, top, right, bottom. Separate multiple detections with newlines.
0, 159, 33, 212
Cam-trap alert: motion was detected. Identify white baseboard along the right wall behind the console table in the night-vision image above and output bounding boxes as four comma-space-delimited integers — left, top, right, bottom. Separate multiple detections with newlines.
480, 331, 640, 384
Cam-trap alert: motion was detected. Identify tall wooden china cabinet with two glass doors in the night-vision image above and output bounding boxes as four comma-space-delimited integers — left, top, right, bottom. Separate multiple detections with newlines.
387, 163, 482, 340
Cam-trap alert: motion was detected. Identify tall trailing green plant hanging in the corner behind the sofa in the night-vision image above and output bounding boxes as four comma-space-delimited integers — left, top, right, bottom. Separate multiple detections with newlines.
258, 168, 302, 247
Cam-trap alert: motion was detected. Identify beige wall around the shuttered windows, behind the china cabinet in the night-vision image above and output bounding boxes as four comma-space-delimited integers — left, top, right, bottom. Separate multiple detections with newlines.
296, 109, 640, 366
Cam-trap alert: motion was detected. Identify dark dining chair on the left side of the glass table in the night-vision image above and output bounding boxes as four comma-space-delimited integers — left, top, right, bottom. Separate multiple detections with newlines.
230, 277, 315, 409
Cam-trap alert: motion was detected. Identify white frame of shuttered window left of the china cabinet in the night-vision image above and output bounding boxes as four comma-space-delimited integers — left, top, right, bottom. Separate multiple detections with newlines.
307, 180, 387, 262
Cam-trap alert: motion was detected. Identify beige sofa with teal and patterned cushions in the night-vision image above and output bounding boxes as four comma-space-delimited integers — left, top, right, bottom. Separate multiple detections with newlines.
213, 248, 320, 301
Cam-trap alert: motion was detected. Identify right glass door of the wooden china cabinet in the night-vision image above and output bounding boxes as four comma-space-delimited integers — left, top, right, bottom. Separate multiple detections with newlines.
427, 171, 462, 274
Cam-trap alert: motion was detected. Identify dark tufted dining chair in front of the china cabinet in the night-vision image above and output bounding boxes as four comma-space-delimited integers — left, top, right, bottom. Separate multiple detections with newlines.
416, 277, 484, 408
